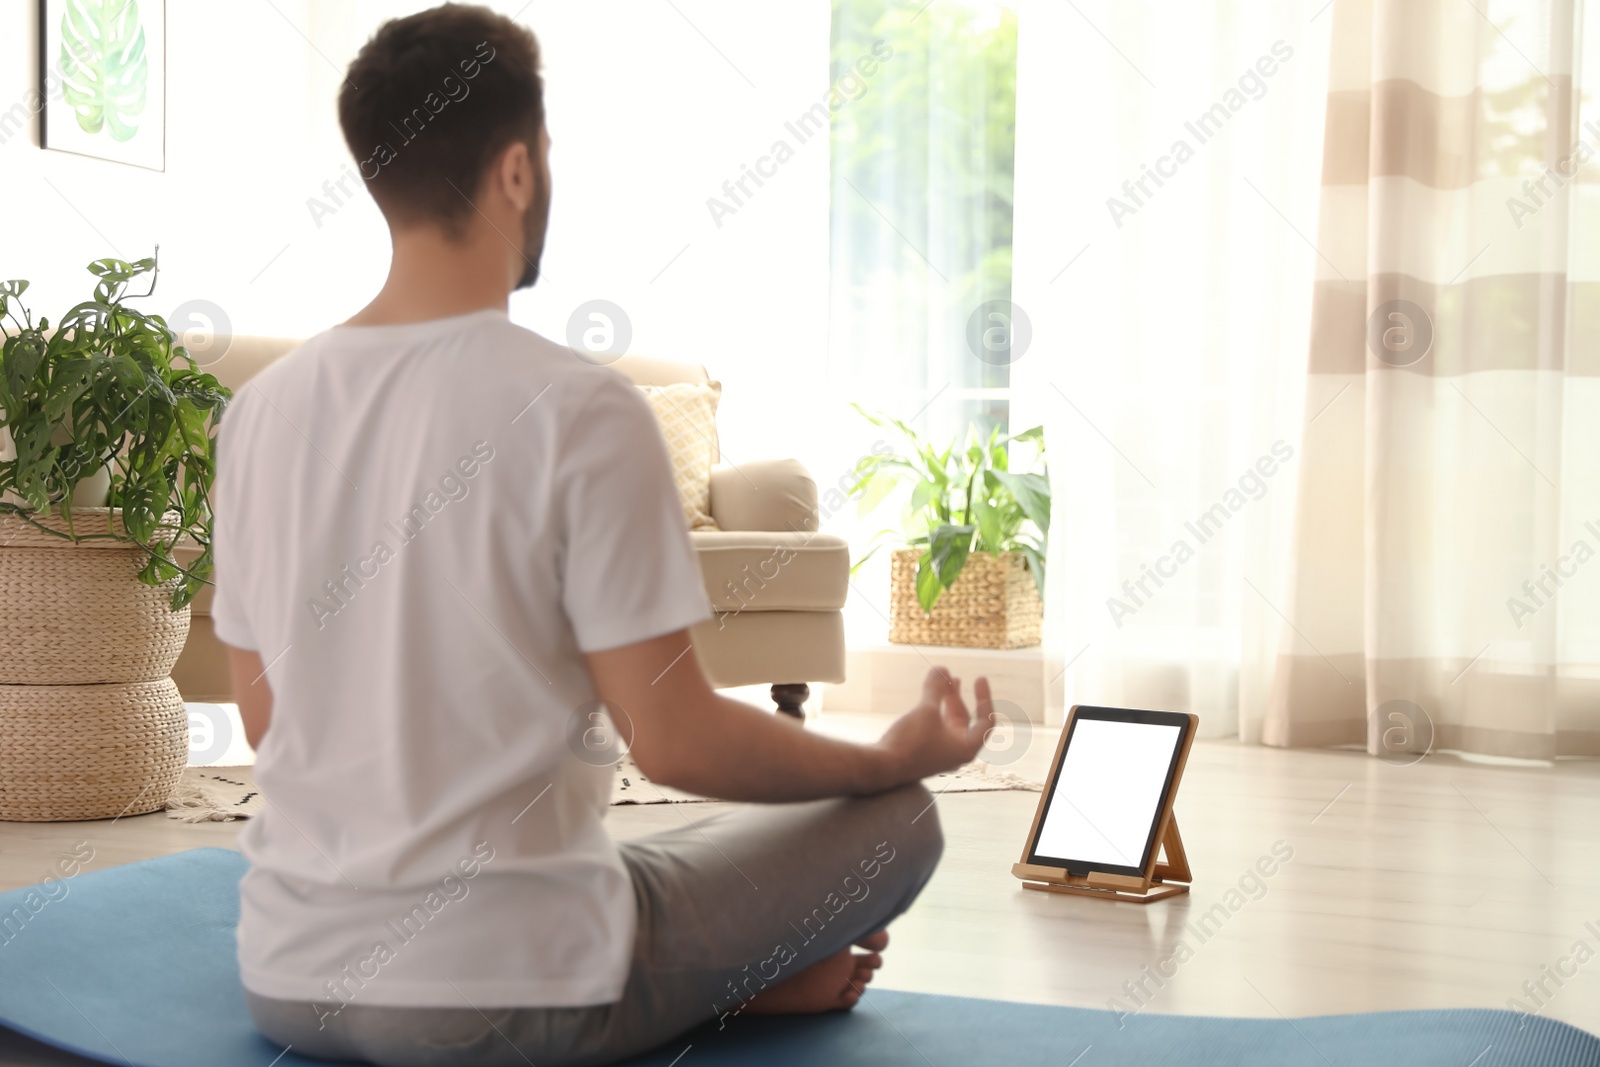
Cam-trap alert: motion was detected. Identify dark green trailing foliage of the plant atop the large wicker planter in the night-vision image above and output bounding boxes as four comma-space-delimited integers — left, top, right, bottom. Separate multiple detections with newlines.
0, 258, 229, 611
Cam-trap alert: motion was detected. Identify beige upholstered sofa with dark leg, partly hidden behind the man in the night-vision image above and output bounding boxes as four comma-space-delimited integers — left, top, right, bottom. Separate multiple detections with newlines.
173, 336, 850, 717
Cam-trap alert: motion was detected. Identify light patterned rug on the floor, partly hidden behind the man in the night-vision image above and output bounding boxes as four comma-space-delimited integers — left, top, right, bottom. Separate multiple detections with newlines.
166, 758, 1042, 822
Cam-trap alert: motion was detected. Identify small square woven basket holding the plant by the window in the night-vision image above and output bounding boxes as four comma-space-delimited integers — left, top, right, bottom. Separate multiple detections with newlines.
890, 549, 1045, 648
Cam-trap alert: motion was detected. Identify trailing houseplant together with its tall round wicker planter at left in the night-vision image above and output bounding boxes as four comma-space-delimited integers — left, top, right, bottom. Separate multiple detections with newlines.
0, 258, 229, 821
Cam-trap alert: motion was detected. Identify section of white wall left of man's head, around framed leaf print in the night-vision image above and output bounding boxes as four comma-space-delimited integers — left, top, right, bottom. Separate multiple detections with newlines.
0, 0, 324, 333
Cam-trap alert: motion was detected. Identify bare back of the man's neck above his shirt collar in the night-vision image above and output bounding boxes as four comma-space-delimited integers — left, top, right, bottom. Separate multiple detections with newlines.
346, 227, 510, 326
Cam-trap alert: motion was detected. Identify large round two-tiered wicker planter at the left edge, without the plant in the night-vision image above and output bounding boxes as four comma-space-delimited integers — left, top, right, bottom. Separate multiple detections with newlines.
0, 507, 189, 822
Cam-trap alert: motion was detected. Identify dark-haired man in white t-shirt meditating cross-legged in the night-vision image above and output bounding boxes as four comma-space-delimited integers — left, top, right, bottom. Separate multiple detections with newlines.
214, 5, 990, 1067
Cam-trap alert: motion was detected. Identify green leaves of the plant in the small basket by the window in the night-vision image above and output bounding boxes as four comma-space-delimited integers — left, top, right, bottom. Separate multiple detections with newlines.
851, 405, 1050, 646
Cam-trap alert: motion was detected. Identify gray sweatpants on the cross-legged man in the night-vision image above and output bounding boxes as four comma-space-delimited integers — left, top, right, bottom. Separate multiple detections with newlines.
245, 785, 944, 1067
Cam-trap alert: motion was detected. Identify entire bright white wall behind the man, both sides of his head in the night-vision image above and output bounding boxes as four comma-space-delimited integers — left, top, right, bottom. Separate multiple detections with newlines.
9, 0, 829, 462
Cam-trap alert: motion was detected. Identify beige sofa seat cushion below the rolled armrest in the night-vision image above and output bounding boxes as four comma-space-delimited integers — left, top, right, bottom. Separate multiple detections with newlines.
690, 530, 850, 614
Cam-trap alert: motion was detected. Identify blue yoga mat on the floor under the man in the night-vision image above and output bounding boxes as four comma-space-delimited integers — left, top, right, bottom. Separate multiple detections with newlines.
0, 848, 1600, 1067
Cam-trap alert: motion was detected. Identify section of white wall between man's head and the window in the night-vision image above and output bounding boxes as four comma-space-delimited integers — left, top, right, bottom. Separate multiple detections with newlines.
492, 0, 842, 462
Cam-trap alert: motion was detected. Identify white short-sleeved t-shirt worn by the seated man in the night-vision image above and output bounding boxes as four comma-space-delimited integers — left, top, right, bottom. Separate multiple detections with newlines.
214, 310, 710, 1008
